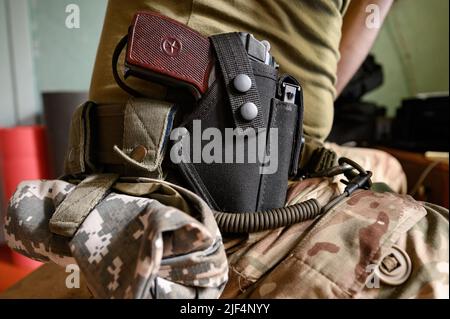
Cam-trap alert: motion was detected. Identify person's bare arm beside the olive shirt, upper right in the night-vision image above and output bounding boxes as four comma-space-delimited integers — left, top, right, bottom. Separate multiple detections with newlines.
336, 0, 393, 96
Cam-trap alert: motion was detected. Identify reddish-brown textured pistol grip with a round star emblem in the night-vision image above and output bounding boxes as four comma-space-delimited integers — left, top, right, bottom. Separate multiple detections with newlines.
125, 12, 213, 97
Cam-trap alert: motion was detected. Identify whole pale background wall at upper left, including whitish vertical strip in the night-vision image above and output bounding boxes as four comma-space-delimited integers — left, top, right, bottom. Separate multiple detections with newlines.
0, 0, 107, 127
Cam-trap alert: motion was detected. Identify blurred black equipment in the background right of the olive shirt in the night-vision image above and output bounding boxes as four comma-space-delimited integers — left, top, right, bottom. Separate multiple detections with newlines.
328, 55, 450, 153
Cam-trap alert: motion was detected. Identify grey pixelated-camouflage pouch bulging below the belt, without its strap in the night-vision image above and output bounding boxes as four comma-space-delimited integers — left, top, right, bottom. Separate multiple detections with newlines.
5, 180, 228, 298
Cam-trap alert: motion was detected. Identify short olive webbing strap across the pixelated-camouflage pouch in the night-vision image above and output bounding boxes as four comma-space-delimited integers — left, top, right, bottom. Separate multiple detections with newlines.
50, 174, 118, 237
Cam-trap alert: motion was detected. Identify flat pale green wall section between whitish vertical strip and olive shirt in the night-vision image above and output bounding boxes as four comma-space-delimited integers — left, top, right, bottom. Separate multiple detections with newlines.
29, 0, 107, 96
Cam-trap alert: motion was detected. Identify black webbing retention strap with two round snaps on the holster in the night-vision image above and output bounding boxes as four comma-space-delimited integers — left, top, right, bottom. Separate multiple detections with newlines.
210, 33, 265, 130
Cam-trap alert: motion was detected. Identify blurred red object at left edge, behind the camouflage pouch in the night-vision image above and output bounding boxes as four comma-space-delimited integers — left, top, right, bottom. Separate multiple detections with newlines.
0, 126, 51, 277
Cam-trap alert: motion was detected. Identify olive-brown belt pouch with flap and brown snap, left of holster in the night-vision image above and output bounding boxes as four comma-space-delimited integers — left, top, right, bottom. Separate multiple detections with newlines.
66, 98, 176, 179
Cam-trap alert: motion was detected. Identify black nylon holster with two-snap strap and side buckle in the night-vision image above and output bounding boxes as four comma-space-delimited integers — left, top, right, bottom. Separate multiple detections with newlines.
174, 33, 303, 212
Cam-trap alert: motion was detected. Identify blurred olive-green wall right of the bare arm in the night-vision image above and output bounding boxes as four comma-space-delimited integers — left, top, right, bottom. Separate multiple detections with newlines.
365, 0, 449, 116
